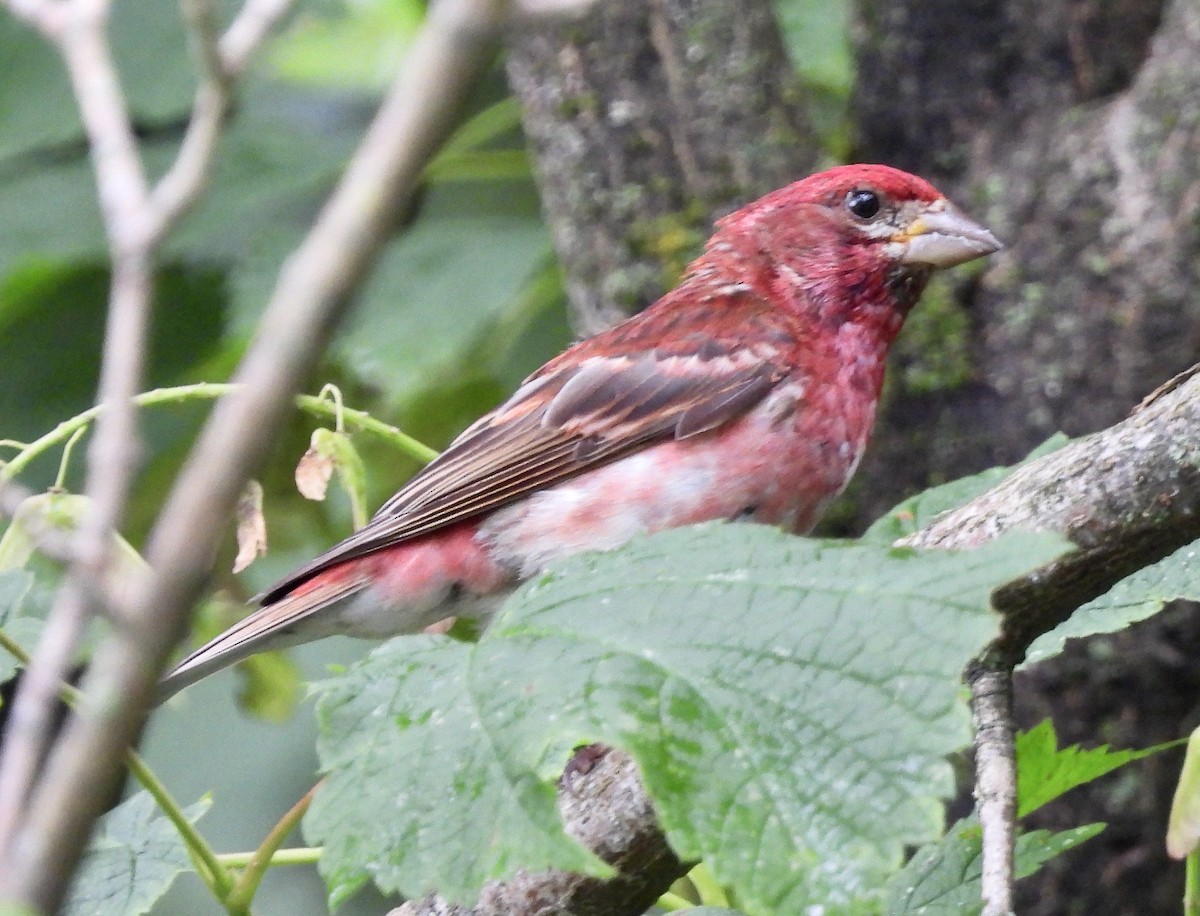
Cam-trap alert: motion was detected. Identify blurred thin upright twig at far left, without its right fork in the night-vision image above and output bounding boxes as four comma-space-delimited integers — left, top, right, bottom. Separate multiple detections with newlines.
0, 0, 152, 859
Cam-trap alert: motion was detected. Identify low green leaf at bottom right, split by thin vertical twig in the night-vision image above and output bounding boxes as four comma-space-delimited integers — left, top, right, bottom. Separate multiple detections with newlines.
884, 814, 1104, 916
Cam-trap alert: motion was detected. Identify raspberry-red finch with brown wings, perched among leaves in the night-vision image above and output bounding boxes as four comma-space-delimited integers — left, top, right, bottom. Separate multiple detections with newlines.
162, 166, 1000, 695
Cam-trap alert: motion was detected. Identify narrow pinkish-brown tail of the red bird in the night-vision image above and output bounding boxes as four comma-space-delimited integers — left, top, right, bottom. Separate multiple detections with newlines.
156, 577, 366, 704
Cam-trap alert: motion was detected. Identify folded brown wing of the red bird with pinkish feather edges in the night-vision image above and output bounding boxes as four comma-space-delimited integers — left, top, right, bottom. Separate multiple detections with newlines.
262, 304, 801, 603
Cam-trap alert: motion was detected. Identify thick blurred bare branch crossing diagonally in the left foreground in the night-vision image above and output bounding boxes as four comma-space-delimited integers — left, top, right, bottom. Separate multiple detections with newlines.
0, 0, 505, 911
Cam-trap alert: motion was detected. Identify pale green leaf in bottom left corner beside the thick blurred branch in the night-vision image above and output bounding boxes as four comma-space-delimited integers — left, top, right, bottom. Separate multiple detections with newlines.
64, 791, 212, 916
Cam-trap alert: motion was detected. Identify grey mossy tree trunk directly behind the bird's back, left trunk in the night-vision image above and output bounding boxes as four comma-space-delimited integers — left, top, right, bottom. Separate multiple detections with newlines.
508, 0, 816, 334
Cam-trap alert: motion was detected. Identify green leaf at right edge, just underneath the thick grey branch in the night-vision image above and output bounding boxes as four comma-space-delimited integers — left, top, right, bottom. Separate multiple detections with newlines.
1025, 541, 1200, 665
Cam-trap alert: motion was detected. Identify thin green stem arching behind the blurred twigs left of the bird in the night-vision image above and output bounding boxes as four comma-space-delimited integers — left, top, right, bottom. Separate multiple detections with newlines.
0, 382, 438, 480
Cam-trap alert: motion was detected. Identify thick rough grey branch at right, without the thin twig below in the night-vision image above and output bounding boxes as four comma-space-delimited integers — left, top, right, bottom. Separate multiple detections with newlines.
904, 366, 1200, 665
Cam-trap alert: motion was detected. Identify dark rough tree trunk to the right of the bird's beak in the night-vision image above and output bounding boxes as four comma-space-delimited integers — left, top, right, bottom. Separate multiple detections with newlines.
854, 0, 1200, 520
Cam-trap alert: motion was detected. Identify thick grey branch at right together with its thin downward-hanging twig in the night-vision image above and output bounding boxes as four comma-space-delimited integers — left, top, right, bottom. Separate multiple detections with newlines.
904, 367, 1200, 914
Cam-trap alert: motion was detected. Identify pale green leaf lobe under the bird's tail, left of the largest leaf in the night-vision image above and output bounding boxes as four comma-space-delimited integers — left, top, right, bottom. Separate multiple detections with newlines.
305, 637, 607, 909
